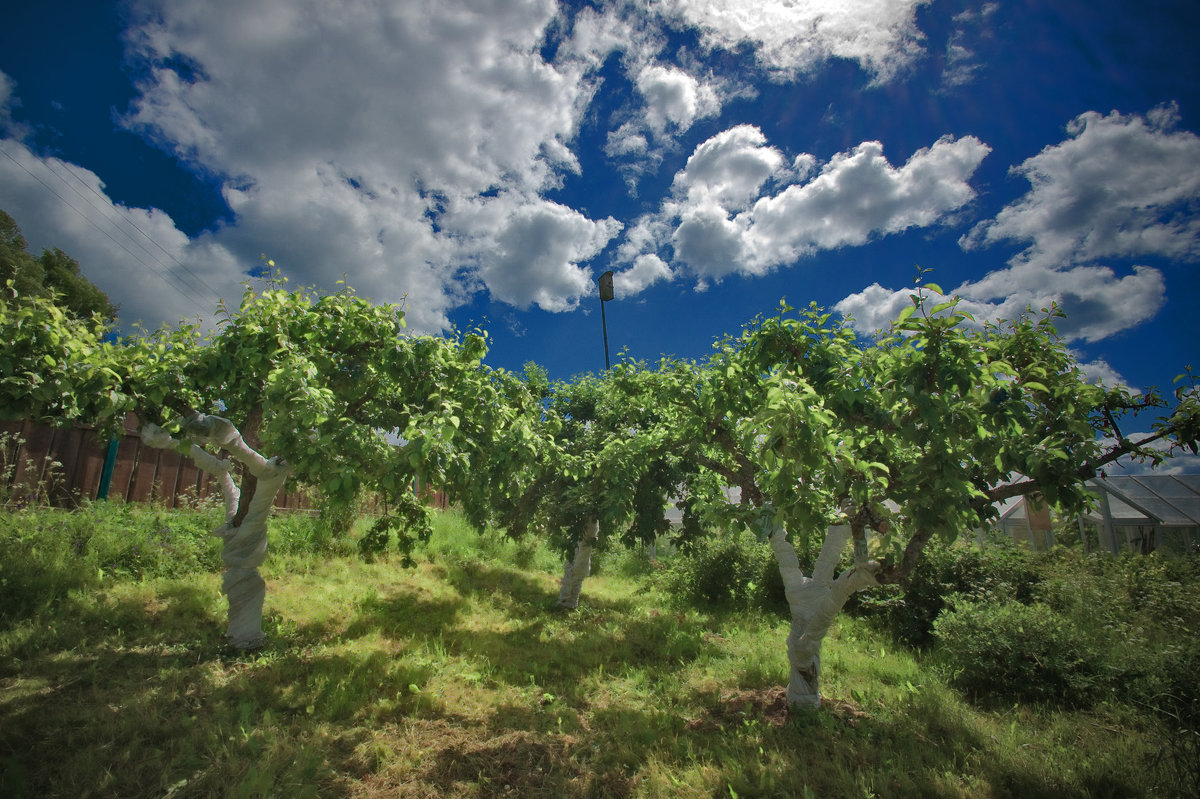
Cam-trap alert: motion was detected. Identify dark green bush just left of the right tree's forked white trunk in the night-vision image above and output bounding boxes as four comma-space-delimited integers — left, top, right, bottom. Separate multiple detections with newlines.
660, 530, 786, 609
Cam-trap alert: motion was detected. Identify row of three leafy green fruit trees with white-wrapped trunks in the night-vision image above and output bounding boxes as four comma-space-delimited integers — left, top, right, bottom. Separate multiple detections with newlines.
0, 271, 1200, 707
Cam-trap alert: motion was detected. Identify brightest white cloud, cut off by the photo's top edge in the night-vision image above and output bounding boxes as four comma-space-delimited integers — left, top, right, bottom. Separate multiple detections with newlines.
652, 0, 928, 82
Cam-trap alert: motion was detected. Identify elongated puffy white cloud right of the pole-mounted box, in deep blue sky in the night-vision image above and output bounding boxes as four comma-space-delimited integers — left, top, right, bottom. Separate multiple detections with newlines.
618, 125, 990, 282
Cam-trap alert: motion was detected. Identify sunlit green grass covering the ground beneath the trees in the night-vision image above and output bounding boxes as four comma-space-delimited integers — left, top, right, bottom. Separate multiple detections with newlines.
0, 509, 1180, 799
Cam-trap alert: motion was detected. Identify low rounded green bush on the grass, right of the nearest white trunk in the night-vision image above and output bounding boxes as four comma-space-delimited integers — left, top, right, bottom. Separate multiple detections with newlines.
934, 599, 1108, 707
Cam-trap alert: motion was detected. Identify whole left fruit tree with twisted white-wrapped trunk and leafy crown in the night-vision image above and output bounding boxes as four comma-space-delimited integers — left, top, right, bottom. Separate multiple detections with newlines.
0, 281, 498, 648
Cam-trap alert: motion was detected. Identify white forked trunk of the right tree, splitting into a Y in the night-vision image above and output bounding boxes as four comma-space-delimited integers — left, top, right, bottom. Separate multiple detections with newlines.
770, 525, 877, 708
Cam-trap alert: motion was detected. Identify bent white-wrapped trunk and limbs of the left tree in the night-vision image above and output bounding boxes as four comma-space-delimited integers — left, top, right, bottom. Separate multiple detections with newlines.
142, 414, 288, 649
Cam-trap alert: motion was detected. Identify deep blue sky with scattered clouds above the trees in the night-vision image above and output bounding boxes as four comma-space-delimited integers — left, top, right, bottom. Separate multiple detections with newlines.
0, 0, 1200, 470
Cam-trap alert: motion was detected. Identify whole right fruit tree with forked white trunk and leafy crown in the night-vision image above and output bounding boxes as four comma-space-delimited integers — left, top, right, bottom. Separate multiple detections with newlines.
643, 286, 1200, 707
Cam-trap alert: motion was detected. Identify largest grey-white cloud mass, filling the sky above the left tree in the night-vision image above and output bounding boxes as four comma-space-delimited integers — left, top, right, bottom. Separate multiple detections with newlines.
111, 0, 614, 330
